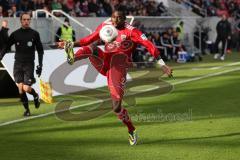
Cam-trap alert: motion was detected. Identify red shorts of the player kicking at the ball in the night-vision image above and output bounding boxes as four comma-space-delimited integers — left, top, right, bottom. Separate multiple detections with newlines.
78, 47, 129, 101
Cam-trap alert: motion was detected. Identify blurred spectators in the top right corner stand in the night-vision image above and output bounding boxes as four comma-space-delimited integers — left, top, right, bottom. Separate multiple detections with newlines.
175, 0, 240, 19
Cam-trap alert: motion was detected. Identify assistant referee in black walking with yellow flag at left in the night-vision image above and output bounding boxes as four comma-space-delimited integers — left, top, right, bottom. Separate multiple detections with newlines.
0, 13, 44, 116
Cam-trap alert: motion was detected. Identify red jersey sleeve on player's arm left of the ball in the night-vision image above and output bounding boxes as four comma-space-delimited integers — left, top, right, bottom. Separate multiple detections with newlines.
79, 24, 103, 46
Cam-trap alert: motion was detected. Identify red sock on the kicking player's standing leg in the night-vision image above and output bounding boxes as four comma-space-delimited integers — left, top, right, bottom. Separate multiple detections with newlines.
117, 108, 135, 132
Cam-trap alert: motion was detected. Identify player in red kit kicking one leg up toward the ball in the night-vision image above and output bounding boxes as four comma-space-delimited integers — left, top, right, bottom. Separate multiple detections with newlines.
58, 10, 172, 145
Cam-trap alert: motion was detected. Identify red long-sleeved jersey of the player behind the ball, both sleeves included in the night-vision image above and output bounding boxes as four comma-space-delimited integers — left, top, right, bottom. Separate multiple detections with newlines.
79, 21, 160, 60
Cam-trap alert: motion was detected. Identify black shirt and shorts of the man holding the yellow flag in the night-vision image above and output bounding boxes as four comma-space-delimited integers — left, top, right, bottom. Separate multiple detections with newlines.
1, 28, 43, 86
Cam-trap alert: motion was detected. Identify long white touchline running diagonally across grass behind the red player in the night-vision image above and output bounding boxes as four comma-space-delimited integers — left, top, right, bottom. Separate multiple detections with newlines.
0, 67, 240, 127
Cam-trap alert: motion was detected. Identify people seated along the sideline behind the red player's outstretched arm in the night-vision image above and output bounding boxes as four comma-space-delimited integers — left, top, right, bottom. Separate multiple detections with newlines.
133, 21, 202, 67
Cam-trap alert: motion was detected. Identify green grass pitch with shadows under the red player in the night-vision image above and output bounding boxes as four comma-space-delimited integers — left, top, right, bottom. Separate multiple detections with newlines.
0, 53, 240, 160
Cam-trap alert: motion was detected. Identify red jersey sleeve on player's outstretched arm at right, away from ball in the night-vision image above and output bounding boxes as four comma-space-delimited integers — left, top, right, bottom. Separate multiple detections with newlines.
131, 29, 160, 59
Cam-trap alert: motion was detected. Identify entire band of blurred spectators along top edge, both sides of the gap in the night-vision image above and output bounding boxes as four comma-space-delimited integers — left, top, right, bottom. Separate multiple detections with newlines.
0, 0, 237, 19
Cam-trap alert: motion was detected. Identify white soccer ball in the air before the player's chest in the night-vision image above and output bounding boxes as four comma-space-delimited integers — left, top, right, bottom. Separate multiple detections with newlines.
99, 25, 118, 43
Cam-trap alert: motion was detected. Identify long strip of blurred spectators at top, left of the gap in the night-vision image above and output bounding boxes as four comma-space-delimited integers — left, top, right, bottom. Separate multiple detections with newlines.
0, 0, 167, 17
